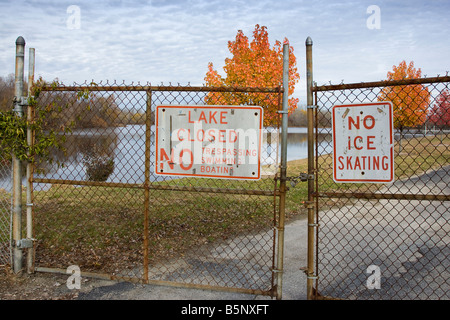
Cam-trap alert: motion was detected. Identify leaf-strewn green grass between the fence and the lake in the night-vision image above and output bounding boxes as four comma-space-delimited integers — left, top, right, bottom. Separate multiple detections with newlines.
0, 132, 450, 273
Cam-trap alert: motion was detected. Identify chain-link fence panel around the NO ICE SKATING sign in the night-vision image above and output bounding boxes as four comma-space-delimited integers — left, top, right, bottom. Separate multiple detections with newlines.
313, 76, 450, 300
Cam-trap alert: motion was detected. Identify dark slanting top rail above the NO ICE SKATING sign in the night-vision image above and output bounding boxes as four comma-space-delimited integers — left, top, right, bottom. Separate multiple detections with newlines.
311, 76, 450, 92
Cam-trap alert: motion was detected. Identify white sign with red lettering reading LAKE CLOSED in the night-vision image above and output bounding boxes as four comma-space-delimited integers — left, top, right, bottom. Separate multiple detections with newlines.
155, 105, 263, 180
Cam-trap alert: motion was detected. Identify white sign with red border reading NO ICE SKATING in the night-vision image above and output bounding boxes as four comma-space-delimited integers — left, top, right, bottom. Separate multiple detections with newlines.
332, 101, 394, 183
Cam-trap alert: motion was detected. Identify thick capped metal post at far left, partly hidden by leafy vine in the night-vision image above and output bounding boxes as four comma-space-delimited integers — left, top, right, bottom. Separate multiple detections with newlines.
12, 37, 25, 273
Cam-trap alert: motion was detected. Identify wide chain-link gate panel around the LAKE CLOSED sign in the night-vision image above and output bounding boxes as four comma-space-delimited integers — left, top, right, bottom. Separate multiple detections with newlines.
33, 83, 281, 296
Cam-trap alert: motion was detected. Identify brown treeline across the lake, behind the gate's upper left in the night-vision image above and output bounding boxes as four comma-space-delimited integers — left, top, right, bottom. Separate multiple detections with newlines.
0, 74, 154, 129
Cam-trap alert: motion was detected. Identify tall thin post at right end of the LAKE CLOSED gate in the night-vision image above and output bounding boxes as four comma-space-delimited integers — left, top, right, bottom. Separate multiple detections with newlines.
277, 43, 289, 300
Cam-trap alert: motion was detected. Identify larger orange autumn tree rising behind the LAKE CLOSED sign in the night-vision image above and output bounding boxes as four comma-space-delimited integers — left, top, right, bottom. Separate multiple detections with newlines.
205, 25, 300, 126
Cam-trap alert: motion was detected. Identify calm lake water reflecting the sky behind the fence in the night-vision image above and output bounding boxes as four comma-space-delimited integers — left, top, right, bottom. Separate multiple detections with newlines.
0, 125, 331, 191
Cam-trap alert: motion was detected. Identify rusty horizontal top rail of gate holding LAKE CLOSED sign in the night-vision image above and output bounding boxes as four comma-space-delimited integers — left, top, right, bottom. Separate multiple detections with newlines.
41, 84, 284, 93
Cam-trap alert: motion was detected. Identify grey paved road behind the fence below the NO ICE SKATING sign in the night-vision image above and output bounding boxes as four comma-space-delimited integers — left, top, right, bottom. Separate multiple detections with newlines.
319, 166, 450, 300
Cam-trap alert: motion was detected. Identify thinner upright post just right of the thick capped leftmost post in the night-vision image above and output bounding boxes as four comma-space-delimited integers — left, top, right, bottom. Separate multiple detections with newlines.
26, 48, 35, 273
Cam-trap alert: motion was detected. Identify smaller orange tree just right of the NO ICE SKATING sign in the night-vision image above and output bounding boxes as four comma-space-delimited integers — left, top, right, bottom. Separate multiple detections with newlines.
378, 61, 430, 133
